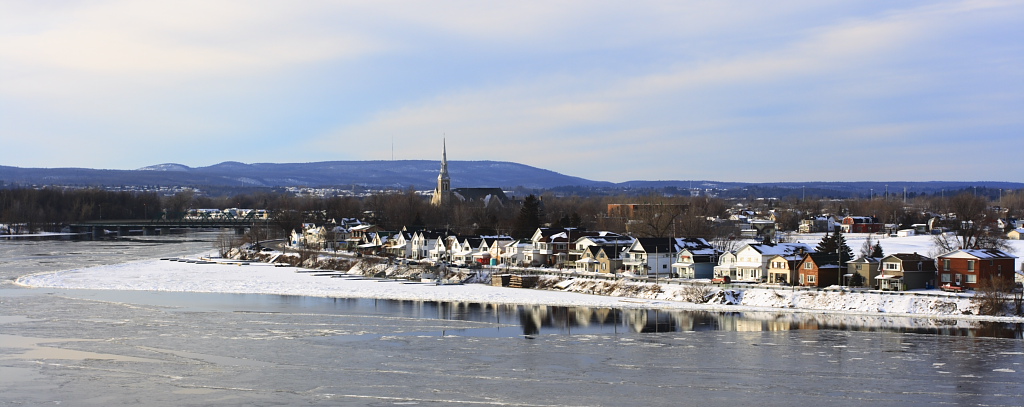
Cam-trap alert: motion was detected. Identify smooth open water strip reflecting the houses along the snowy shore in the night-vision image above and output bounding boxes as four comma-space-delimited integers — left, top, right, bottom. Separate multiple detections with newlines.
49, 290, 1024, 339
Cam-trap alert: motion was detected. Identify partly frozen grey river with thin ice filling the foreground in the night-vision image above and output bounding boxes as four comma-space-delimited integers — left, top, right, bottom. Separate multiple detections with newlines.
0, 234, 1024, 406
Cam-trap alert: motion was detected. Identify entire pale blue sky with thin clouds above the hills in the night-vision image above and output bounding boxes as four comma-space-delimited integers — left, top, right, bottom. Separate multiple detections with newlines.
0, 0, 1024, 182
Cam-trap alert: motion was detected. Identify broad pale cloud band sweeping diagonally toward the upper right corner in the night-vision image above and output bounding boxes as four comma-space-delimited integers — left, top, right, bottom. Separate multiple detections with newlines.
317, 3, 1024, 180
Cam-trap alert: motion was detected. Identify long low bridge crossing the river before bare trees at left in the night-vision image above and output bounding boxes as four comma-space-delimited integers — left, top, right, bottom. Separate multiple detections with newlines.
69, 218, 267, 237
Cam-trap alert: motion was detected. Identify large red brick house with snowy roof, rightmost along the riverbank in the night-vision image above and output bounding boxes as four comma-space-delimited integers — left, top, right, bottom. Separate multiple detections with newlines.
936, 249, 1017, 289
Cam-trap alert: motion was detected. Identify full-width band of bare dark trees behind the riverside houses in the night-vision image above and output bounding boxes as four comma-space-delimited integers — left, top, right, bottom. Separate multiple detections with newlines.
0, 188, 1024, 247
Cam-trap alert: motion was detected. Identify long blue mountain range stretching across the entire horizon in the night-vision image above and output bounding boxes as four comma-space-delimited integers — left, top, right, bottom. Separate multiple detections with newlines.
0, 160, 1024, 198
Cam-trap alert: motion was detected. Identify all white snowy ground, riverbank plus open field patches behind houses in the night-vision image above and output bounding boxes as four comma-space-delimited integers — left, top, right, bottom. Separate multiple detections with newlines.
17, 235, 1024, 322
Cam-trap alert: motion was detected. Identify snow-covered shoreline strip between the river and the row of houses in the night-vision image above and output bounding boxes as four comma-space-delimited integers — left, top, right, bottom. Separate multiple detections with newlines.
13, 254, 1024, 323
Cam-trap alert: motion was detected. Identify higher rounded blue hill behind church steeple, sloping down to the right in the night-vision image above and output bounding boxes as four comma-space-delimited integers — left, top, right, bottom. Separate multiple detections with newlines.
0, 160, 612, 190
